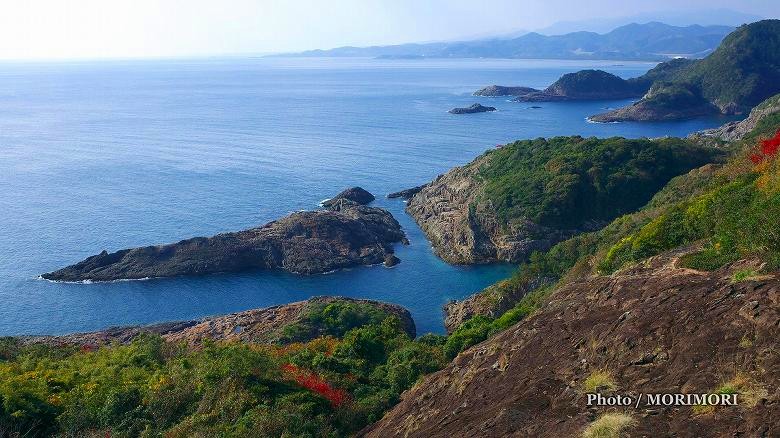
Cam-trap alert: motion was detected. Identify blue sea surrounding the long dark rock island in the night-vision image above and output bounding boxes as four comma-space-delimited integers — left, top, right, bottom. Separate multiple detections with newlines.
0, 58, 736, 335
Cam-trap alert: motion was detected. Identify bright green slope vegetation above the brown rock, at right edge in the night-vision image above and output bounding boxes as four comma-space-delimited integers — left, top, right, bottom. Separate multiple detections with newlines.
446, 95, 780, 357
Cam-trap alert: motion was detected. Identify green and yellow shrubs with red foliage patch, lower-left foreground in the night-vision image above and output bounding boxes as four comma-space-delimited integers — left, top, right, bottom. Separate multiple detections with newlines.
0, 314, 446, 437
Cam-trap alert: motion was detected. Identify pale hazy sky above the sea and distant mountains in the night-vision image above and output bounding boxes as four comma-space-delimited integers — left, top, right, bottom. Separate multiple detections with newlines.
0, 0, 780, 59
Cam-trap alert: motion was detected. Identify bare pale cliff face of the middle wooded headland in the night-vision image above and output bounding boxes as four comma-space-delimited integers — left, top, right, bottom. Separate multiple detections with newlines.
406, 154, 573, 264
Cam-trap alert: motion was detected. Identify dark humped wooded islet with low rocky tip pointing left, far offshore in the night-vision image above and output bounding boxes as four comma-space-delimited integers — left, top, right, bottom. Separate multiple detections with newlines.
513, 70, 646, 102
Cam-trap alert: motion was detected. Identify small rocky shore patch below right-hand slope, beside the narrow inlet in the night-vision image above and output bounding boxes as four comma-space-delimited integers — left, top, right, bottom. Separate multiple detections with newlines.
444, 277, 555, 333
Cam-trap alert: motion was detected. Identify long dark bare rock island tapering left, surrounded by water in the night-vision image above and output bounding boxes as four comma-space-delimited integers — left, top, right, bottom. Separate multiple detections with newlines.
42, 187, 408, 281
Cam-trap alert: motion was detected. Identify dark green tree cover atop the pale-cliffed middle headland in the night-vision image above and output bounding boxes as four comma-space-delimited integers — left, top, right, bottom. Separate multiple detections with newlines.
480, 136, 721, 229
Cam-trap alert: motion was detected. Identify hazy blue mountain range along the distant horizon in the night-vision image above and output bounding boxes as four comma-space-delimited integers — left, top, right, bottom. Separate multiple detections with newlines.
284, 22, 734, 61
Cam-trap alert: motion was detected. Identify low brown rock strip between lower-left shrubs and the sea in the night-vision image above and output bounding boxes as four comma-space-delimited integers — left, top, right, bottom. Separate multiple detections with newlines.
20, 296, 416, 347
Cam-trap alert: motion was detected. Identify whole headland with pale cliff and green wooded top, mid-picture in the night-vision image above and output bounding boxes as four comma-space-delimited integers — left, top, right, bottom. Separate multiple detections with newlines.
406, 136, 720, 264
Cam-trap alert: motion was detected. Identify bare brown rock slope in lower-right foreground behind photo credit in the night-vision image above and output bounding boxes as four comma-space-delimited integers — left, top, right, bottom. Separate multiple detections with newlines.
361, 248, 780, 437
